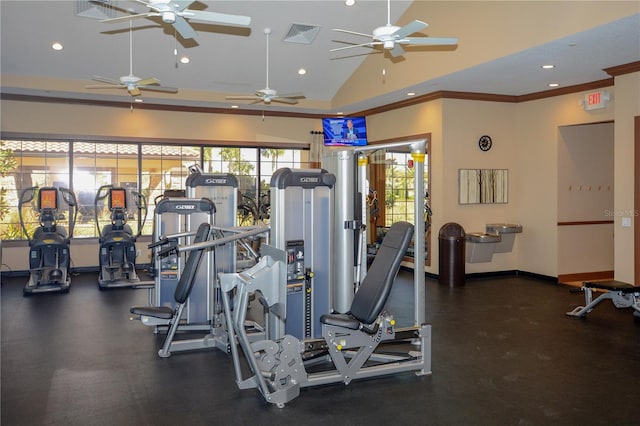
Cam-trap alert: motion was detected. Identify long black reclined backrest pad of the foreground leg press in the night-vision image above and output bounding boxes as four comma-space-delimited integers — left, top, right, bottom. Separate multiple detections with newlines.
350, 222, 413, 324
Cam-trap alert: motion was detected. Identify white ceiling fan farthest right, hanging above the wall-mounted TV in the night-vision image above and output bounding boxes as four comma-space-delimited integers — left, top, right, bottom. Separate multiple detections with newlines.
330, 0, 458, 58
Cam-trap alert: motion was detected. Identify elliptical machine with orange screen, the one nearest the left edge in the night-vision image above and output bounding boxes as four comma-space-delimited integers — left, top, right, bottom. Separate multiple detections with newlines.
18, 186, 78, 296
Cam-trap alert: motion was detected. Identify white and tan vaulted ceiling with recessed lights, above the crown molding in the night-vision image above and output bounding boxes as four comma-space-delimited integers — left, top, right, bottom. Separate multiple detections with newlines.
0, 0, 640, 113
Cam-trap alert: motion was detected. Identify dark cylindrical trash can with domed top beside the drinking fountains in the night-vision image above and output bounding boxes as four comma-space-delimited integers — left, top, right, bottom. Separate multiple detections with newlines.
438, 222, 466, 287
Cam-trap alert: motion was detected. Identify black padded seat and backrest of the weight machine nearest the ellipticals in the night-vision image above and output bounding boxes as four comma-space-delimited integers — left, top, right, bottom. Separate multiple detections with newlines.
130, 222, 211, 321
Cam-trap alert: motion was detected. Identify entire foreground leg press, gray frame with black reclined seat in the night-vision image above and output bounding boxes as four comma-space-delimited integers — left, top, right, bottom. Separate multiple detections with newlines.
219, 222, 431, 408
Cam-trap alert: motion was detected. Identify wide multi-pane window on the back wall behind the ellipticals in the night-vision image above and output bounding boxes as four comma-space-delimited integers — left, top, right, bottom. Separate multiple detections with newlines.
0, 139, 308, 240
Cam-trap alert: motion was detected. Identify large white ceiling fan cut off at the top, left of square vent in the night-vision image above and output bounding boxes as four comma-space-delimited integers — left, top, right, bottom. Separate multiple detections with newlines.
100, 0, 251, 39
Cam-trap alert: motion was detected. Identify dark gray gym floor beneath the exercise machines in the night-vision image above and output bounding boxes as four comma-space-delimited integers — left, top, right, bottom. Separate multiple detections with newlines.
1, 271, 640, 426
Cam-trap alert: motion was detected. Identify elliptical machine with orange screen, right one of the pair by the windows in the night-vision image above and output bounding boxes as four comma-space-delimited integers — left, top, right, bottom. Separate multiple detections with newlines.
94, 185, 147, 290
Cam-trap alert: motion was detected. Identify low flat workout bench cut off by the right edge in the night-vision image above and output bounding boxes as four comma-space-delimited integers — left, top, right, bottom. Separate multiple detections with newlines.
567, 280, 640, 318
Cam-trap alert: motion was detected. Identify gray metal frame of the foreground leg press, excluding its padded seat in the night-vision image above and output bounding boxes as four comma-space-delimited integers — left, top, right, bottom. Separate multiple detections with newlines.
219, 248, 431, 408
